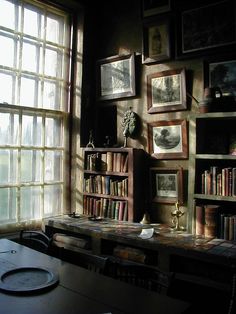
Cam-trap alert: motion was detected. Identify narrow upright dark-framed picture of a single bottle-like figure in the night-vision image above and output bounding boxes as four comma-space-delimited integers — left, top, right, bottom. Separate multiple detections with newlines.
142, 18, 171, 64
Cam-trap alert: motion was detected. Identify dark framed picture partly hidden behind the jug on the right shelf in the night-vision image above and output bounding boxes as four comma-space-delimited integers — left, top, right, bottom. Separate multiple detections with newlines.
204, 60, 236, 100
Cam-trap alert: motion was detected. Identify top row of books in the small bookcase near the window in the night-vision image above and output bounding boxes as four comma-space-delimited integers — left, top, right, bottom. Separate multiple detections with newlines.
86, 152, 128, 172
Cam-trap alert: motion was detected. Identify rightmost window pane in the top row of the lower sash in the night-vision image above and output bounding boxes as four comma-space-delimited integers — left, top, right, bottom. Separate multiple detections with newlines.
45, 118, 62, 147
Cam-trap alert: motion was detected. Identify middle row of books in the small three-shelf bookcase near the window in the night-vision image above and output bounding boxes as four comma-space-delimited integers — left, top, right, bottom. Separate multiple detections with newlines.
84, 175, 128, 197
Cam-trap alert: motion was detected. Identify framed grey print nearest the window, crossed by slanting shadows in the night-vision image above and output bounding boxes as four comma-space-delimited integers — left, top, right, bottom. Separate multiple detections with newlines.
97, 54, 136, 100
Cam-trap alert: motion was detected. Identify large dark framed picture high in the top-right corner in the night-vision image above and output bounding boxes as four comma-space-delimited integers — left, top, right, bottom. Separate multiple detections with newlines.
177, 0, 236, 55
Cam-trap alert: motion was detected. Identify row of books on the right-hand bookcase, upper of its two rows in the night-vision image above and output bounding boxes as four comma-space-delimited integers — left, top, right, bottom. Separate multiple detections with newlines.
201, 166, 236, 196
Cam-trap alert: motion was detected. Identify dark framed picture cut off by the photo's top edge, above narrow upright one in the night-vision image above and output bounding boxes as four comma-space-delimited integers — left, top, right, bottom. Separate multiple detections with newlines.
142, 0, 170, 17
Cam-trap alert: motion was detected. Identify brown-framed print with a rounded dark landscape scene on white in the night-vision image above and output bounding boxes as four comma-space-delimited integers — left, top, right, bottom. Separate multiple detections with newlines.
148, 120, 188, 159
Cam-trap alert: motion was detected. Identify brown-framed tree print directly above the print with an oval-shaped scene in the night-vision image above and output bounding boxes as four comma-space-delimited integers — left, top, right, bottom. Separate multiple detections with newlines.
147, 69, 187, 113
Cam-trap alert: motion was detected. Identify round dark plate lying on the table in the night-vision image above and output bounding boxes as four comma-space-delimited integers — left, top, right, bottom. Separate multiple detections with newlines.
0, 267, 59, 293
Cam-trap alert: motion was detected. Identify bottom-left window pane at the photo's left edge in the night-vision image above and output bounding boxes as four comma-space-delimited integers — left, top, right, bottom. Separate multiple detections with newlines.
0, 188, 16, 223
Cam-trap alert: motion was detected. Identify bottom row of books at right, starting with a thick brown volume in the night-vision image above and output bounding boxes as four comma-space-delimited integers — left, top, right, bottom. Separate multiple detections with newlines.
195, 205, 236, 241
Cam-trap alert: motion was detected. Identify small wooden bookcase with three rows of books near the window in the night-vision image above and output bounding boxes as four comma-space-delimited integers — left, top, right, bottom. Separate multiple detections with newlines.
83, 148, 147, 222
